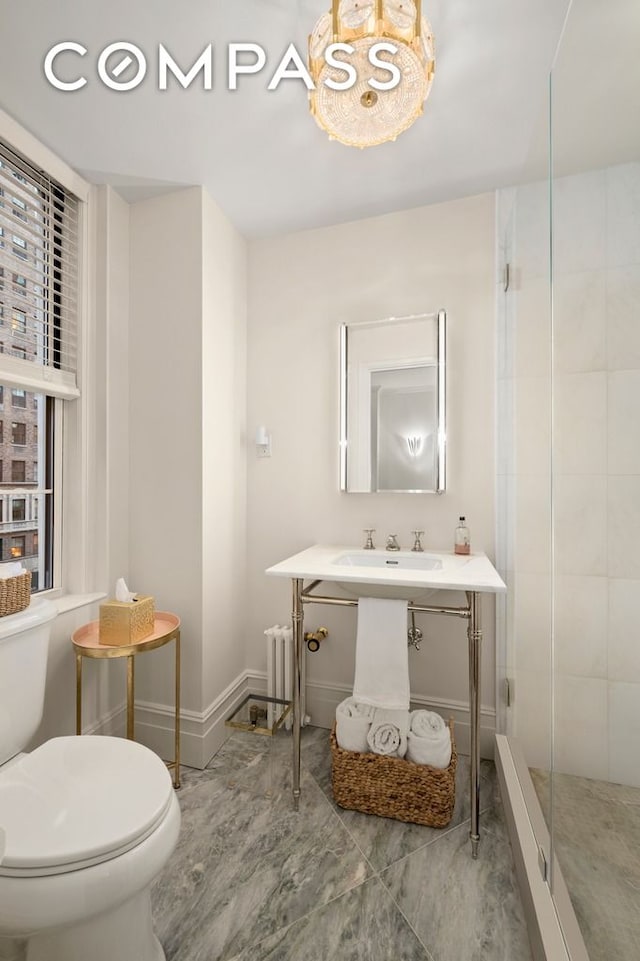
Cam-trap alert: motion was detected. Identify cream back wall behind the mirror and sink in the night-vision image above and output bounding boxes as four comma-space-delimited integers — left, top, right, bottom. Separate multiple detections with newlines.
246, 194, 495, 752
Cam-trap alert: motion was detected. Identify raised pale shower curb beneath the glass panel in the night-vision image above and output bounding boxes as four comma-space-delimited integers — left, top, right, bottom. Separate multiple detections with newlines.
496, 734, 589, 961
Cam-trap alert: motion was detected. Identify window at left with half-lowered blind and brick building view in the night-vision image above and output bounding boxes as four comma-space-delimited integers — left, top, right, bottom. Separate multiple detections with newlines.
0, 141, 84, 591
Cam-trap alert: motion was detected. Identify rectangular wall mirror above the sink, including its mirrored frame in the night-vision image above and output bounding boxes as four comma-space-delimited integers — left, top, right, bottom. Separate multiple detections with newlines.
340, 310, 447, 494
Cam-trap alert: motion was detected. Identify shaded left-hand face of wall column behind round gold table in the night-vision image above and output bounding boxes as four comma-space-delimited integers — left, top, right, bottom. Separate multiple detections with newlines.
128, 187, 203, 711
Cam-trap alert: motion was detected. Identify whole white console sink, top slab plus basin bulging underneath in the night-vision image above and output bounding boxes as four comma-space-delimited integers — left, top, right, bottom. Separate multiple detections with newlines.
267, 544, 506, 603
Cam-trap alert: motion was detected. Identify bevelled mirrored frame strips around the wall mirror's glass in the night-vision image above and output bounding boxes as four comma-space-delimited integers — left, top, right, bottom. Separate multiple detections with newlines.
340, 308, 447, 494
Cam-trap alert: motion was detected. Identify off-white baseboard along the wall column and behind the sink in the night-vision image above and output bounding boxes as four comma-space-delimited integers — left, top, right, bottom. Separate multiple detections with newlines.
91, 670, 496, 769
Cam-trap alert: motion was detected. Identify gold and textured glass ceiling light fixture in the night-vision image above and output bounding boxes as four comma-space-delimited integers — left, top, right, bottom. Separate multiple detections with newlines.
309, 0, 435, 147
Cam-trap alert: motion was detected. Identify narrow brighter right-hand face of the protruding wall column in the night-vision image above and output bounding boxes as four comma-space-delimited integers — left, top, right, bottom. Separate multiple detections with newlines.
201, 192, 247, 708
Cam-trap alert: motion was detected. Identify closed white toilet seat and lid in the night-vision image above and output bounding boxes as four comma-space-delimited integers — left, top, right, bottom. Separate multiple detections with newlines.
0, 736, 174, 878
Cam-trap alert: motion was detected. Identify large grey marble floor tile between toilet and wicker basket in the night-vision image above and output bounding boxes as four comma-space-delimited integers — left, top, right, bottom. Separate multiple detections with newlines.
153, 764, 371, 961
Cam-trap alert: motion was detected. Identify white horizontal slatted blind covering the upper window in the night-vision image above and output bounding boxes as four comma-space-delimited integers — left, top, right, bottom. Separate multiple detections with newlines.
0, 142, 79, 398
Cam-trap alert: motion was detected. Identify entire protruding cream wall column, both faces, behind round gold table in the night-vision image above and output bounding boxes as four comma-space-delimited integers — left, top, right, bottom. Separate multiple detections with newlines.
129, 187, 246, 766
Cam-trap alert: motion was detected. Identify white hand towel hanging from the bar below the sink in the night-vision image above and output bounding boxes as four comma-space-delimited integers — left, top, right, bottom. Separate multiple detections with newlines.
353, 597, 409, 711
